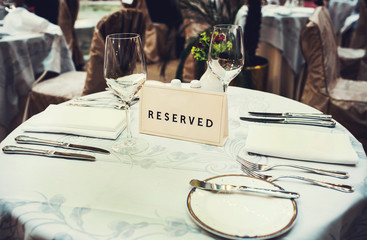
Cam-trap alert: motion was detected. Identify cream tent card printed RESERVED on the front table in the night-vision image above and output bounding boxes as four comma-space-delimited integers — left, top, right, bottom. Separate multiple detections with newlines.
139, 84, 228, 146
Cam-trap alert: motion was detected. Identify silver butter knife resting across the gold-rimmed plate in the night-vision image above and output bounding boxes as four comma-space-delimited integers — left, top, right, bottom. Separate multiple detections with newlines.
190, 179, 300, 198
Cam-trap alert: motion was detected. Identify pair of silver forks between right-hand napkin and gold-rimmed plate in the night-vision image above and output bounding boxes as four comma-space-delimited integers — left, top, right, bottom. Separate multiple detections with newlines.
237, 156, 354, 193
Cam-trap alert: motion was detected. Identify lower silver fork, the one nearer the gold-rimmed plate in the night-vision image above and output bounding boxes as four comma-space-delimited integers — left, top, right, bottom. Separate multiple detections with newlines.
241, 165, 354, 193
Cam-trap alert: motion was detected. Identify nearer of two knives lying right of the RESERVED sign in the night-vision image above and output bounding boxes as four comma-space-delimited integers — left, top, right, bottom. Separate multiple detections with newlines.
240, 117, 336, 128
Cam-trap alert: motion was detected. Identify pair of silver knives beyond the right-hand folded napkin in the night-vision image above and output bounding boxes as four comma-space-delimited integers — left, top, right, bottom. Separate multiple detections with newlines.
240, 112, 336, 128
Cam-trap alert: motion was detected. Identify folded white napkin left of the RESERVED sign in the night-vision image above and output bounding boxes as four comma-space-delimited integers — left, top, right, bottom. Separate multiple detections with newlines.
23, 105, 125, 139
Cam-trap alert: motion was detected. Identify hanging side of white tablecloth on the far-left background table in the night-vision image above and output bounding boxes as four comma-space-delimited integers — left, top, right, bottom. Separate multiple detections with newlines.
0, 31, 75, 139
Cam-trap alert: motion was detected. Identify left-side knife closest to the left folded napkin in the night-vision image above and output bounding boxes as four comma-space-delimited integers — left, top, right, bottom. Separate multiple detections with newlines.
15, 135, 110, 154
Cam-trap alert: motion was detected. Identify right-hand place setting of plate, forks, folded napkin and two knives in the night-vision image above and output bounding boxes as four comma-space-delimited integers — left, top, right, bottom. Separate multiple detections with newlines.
187, 100, 359, 239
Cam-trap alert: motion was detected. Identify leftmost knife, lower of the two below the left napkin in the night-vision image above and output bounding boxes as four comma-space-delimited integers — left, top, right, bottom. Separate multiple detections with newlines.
3, 146, 96, 161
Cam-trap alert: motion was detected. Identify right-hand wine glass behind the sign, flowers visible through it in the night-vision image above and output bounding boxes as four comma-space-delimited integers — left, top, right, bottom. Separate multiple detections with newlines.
208, 24, 245, 92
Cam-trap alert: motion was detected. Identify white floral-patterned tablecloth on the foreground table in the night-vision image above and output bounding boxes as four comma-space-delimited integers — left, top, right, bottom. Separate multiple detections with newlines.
0, 87, 367, 240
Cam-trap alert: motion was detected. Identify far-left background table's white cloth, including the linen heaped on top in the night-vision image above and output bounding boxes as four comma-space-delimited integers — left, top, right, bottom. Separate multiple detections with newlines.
0, 7, 75, 133
